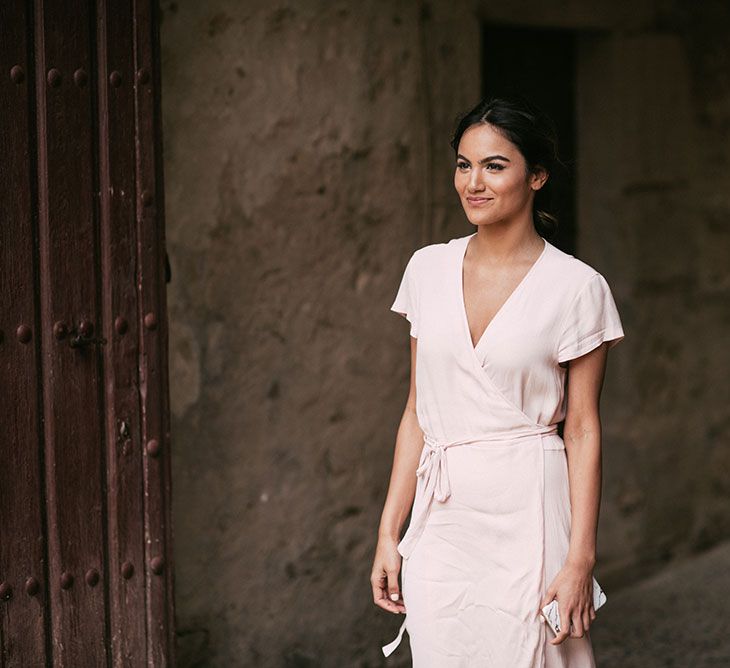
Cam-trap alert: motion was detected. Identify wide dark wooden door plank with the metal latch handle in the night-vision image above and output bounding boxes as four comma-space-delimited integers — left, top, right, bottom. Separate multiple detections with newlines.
35, 0, 109, 666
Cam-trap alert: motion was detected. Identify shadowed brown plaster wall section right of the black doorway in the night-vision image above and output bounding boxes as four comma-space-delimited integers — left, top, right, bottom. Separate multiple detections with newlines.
579, 3, 730, 582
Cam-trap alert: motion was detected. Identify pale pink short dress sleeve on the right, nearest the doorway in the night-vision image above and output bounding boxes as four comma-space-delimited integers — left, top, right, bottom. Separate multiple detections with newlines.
558, 273, 624, 362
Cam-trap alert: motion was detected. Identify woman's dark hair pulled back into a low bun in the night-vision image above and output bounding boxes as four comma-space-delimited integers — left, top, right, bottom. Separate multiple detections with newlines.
451, 95, 563, 239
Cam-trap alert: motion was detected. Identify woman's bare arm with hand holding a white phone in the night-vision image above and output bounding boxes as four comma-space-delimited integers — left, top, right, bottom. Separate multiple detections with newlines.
541, 343, 608, 645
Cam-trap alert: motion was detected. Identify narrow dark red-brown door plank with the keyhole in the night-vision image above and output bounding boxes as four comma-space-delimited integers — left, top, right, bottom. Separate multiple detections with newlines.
97, 1, 146, 666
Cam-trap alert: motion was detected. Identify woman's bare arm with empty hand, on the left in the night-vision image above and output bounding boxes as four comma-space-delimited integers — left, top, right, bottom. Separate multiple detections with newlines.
370, 337, 423, 613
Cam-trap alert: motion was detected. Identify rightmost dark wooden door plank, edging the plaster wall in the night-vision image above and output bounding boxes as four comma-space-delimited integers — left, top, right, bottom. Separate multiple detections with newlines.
134, 0, 175, 666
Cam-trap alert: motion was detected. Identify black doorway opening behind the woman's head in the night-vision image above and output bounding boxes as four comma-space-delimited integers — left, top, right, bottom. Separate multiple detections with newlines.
482, 24, 576, 254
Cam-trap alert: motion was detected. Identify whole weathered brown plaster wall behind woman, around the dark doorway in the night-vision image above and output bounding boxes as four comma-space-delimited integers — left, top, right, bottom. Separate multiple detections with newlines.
162, 0, 730, 667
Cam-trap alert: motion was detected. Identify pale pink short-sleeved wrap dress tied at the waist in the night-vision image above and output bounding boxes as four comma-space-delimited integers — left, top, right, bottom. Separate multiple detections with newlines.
382, 232, 624, 668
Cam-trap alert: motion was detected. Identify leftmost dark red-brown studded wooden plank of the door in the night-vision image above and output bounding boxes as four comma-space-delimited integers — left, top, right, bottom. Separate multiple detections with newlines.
0, 2, 50, 666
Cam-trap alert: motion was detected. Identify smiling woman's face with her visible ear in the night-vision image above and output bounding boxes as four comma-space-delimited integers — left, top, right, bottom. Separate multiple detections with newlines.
454, 124, 547, 230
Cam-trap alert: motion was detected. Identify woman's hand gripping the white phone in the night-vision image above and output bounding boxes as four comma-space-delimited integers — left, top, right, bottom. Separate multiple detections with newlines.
540, 561, 596, 645
